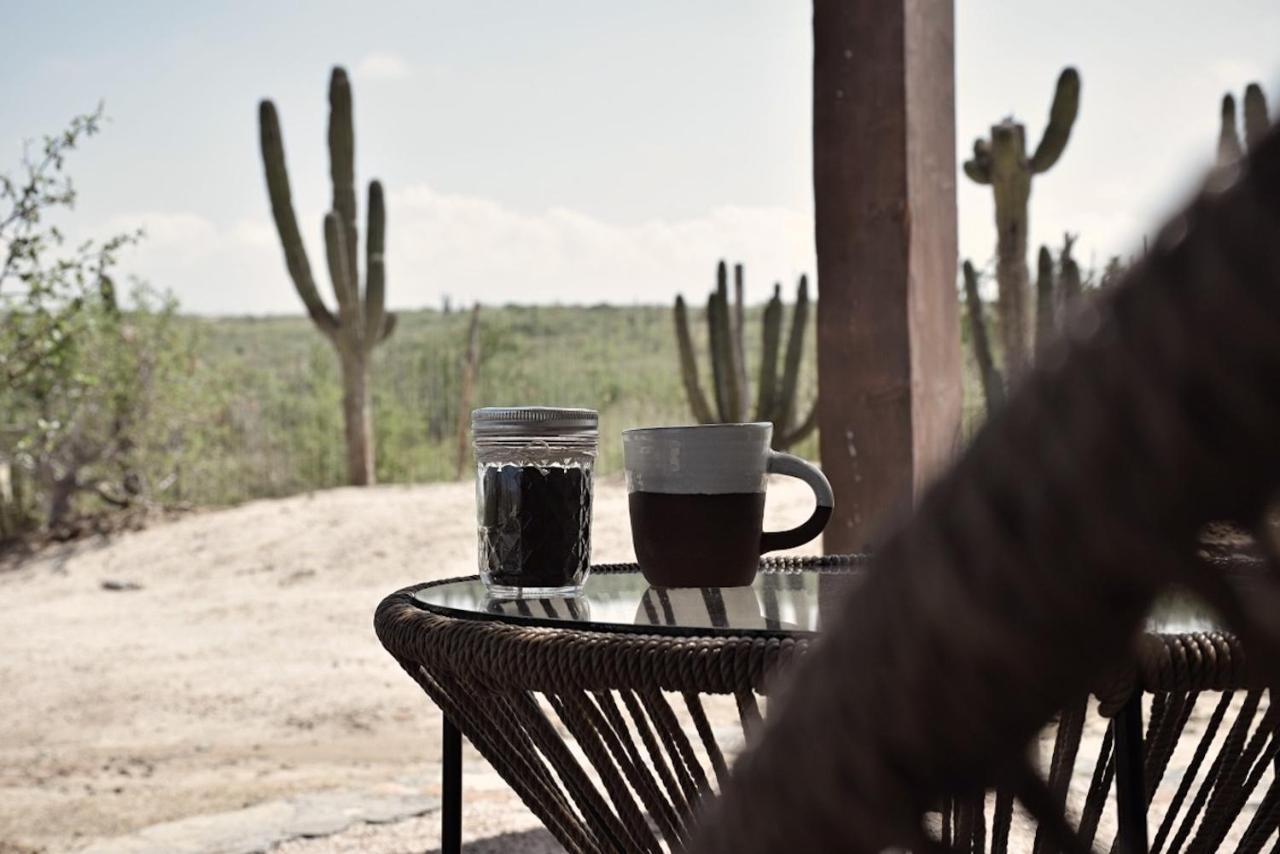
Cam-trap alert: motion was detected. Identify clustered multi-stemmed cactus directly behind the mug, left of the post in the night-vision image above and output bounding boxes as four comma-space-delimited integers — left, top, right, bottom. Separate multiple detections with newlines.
675, 261, 818, 451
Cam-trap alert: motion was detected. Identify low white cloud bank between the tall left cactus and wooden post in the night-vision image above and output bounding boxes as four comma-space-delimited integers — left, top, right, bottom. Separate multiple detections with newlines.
388, 186, 814, 303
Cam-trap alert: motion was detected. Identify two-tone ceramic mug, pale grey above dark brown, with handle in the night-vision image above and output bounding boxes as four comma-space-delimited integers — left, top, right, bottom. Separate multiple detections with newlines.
622, 423, 833, 588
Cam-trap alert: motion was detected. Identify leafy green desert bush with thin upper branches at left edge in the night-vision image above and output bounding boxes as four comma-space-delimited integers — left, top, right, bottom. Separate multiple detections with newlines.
0, 109, 202, 536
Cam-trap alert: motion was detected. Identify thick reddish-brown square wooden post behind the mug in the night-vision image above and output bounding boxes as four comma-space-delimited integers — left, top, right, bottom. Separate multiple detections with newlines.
813, 0, 961, 552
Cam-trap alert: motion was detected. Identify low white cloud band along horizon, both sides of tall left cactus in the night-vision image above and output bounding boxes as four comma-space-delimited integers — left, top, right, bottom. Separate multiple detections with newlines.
90, 184, 814, 314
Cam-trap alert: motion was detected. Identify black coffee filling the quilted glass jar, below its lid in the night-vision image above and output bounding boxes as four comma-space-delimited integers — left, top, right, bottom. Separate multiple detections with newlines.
479, 465, 591, 589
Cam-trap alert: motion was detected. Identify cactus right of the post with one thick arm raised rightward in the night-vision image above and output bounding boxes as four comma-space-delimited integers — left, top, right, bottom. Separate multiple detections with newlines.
964, 68, 1080, 378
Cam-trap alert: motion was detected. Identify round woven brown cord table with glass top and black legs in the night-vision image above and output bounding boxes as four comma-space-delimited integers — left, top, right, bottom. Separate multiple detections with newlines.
375, 557, 1280, 853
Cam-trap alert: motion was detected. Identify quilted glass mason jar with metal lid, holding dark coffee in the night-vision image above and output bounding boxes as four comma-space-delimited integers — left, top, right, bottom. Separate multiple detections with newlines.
471, 406, 599, 598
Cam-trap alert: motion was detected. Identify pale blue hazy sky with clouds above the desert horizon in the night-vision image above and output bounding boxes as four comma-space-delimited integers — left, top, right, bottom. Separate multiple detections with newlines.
0, 0, 1280, 314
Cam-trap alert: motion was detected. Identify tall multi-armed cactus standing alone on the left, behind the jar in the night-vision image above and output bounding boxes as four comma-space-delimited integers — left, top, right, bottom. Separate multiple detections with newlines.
257, 67, 396, 485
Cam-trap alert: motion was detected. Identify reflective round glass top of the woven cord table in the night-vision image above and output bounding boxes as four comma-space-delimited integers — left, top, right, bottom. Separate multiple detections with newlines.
413, 567, 1219, 636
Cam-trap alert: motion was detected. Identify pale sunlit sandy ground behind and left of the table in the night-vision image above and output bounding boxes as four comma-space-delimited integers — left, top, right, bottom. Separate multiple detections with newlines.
0, 479, 813, 854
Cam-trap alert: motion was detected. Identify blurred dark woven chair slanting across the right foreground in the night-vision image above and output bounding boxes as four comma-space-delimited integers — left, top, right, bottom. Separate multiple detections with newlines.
690, 126, 1280, 854
